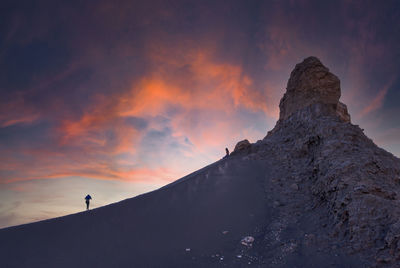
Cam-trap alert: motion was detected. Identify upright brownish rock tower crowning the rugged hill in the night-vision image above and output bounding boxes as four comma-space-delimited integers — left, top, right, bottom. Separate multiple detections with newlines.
279, 57, 350, 122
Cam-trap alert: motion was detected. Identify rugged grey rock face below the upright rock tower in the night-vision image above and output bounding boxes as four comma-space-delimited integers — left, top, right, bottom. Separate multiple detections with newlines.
253, 107, 400, 267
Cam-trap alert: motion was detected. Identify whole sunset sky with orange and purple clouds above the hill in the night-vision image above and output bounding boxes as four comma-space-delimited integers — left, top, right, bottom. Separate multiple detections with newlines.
0, 0, 400, 228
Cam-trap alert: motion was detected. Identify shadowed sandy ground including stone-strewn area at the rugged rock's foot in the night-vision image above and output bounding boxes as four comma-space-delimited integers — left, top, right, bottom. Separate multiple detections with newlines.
0, 152, 366, 267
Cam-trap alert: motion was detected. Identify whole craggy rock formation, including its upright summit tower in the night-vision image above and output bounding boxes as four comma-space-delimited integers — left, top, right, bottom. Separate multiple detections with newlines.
246, 57, 400, 267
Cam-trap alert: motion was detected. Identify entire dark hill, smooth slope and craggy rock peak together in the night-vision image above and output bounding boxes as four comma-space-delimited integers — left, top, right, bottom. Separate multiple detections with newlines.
0, 57, 400, 267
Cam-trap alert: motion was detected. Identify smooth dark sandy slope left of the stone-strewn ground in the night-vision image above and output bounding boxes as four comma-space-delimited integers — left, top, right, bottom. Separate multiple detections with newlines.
0, 159, 267, 267
